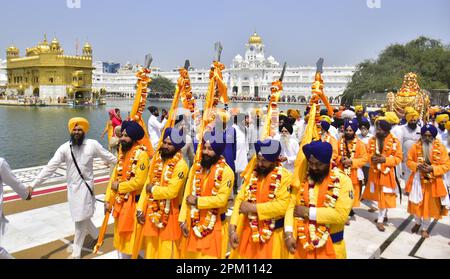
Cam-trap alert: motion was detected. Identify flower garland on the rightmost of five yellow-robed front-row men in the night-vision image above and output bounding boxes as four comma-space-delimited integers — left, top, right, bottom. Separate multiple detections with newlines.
295, 163, 341, 251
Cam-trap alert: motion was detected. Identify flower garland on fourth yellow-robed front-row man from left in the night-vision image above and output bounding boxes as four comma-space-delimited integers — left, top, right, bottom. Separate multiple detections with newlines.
246, 164, 283, 243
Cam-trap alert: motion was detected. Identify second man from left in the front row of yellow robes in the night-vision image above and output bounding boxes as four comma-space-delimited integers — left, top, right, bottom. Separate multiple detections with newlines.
136, 128, 189, 259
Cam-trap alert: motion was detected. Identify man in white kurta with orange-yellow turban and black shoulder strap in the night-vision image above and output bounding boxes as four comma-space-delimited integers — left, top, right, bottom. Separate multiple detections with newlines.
31, 117, 117, 258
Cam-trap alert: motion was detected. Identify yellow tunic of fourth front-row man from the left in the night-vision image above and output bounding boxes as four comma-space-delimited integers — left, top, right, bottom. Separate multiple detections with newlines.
230, 168, 292, 259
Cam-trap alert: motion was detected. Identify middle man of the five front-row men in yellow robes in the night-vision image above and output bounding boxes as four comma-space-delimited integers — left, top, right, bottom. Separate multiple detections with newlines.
178, 130, 235, 259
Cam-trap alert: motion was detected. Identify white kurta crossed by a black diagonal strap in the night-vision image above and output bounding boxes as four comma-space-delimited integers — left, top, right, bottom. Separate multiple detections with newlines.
32, 139, 117, 222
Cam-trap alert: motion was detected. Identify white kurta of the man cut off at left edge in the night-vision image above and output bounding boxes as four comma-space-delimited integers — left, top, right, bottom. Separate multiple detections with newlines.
0, 160, 28, 239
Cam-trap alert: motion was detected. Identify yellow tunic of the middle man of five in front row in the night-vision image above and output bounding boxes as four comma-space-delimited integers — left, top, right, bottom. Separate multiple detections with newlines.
178, 164, 234, 259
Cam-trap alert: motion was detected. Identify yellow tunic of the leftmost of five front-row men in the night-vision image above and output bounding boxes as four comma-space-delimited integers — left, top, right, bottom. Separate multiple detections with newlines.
105, 152, 150, 255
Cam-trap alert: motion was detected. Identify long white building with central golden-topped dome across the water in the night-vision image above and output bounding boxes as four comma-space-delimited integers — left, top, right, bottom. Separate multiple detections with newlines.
93, 32, 355, 103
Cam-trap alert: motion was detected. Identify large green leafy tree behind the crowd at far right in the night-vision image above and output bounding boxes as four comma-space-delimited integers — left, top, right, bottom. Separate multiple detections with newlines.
341, 37, 450, 105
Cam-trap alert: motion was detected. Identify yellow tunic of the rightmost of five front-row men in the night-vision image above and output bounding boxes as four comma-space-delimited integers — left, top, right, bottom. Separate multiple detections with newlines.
284, 171, 353, 259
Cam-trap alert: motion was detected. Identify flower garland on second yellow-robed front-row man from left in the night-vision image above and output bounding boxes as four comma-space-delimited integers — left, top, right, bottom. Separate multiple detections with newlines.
147, 152, 183, 229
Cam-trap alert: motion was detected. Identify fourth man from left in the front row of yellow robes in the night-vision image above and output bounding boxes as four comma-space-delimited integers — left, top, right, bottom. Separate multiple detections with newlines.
229, 139, 292, 259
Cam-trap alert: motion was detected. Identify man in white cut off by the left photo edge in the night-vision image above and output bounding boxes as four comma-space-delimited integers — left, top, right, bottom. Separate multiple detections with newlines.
0, 157, 33, 259
